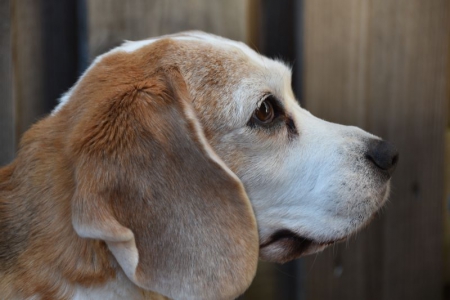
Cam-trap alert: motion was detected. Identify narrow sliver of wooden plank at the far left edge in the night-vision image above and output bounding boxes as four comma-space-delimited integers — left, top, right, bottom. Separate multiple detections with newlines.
0, 0, 16, 166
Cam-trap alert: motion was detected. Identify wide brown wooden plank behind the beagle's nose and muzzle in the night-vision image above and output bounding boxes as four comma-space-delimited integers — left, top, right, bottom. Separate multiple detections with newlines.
303, 0, 450, 299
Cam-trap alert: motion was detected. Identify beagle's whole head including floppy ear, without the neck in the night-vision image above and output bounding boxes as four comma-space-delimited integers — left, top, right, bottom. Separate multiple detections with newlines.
52, 32, 397, 299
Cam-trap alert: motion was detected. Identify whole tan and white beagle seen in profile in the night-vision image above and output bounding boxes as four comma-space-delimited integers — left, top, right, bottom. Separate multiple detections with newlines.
0, 32, 398, 299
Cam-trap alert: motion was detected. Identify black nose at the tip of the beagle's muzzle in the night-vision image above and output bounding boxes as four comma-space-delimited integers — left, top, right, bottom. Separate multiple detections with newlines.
366, 139, 398, 176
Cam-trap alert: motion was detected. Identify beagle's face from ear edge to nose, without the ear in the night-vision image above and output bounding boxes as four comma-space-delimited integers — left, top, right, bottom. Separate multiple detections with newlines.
134, 33, 397, 262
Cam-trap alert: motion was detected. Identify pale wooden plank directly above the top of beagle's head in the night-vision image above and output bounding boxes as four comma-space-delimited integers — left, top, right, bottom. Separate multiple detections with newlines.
86, 0, 248, 59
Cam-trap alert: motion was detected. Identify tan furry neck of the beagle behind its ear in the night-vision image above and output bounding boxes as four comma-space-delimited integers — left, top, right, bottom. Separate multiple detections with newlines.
0, 120, 165, 299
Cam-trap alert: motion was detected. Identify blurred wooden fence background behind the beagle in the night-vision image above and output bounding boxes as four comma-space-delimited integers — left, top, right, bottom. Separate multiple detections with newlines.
0, 0, 450, 300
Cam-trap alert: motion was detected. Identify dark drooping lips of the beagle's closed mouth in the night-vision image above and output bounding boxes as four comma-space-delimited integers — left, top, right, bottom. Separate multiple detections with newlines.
259, 229, 345, 263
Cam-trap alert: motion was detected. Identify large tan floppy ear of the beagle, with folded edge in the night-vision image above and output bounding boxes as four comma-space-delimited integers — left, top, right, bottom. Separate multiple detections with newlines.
72, 69, 259, 299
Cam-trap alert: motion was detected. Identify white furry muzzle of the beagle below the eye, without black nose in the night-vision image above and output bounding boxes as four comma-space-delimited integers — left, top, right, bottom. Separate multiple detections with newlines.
248, 107, 388, 242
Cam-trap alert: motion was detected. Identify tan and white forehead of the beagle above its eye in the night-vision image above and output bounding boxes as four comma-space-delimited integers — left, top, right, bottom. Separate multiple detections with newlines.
117, 31, 294, 125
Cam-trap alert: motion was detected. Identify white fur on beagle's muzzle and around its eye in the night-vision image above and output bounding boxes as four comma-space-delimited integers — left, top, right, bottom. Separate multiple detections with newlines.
218, 72, 389, 250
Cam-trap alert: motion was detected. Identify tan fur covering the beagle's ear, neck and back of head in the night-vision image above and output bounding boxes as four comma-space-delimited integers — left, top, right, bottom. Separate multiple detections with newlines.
0, 40, 258, 299
